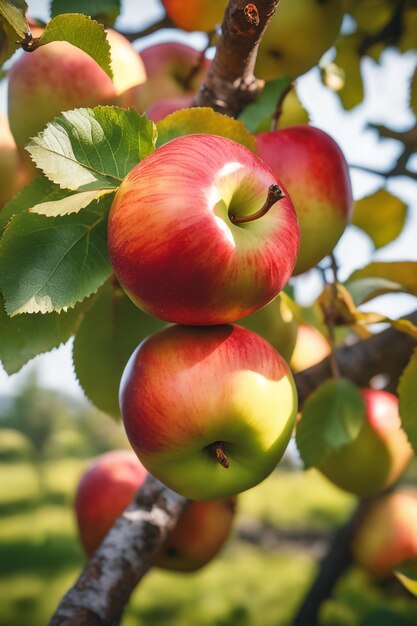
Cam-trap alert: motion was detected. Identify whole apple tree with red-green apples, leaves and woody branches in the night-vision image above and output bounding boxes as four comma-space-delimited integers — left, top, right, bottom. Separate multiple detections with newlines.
0, 0, 417, 626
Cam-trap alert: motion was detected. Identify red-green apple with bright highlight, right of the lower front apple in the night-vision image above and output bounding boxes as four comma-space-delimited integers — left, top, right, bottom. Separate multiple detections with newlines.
317, 389, 413, 497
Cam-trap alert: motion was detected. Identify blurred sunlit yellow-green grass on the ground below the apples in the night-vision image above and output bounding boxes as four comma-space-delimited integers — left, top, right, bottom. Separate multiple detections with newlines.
0, 458, 417, 626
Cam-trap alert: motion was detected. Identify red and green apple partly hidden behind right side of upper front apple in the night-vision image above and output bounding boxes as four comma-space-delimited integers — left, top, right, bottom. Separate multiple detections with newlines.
257, 125, 353, 275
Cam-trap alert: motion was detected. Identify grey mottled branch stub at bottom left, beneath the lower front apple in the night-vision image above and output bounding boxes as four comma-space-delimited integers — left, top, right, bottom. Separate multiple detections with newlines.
50, 476, 187, 626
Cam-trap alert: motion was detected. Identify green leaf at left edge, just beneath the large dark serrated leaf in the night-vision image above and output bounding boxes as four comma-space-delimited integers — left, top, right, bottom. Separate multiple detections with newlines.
0, 296, 91, 375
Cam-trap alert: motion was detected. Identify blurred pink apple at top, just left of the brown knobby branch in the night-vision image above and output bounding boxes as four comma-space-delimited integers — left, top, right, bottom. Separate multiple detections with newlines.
134, 41, 210, 111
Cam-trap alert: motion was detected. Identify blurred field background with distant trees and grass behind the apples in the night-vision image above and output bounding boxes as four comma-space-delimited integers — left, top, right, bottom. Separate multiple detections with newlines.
0, 370, 417, 626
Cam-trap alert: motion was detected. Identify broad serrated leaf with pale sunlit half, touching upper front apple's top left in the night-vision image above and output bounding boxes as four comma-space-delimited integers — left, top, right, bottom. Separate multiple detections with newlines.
27, 106, 156, 191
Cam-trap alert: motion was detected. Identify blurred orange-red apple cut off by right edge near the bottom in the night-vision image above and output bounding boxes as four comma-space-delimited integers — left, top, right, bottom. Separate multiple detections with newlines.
352, 489, 417, 579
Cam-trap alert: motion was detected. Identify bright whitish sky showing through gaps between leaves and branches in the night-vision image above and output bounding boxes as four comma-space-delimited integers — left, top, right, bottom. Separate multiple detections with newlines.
0, 0, 417, 395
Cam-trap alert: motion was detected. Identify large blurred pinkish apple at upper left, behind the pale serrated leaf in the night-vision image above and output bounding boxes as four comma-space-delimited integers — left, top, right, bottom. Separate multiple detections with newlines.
8, 30, 146, 161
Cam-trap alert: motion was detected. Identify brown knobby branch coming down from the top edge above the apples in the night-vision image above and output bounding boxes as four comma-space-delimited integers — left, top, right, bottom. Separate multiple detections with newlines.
195, 0, 279, 117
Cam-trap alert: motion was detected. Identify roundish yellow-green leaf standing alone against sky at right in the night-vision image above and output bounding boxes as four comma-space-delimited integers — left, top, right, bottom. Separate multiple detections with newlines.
352, 189, 407, 248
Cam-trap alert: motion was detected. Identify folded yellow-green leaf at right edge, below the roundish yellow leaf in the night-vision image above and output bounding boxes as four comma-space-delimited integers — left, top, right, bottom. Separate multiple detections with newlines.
345, 261, 417, 305
